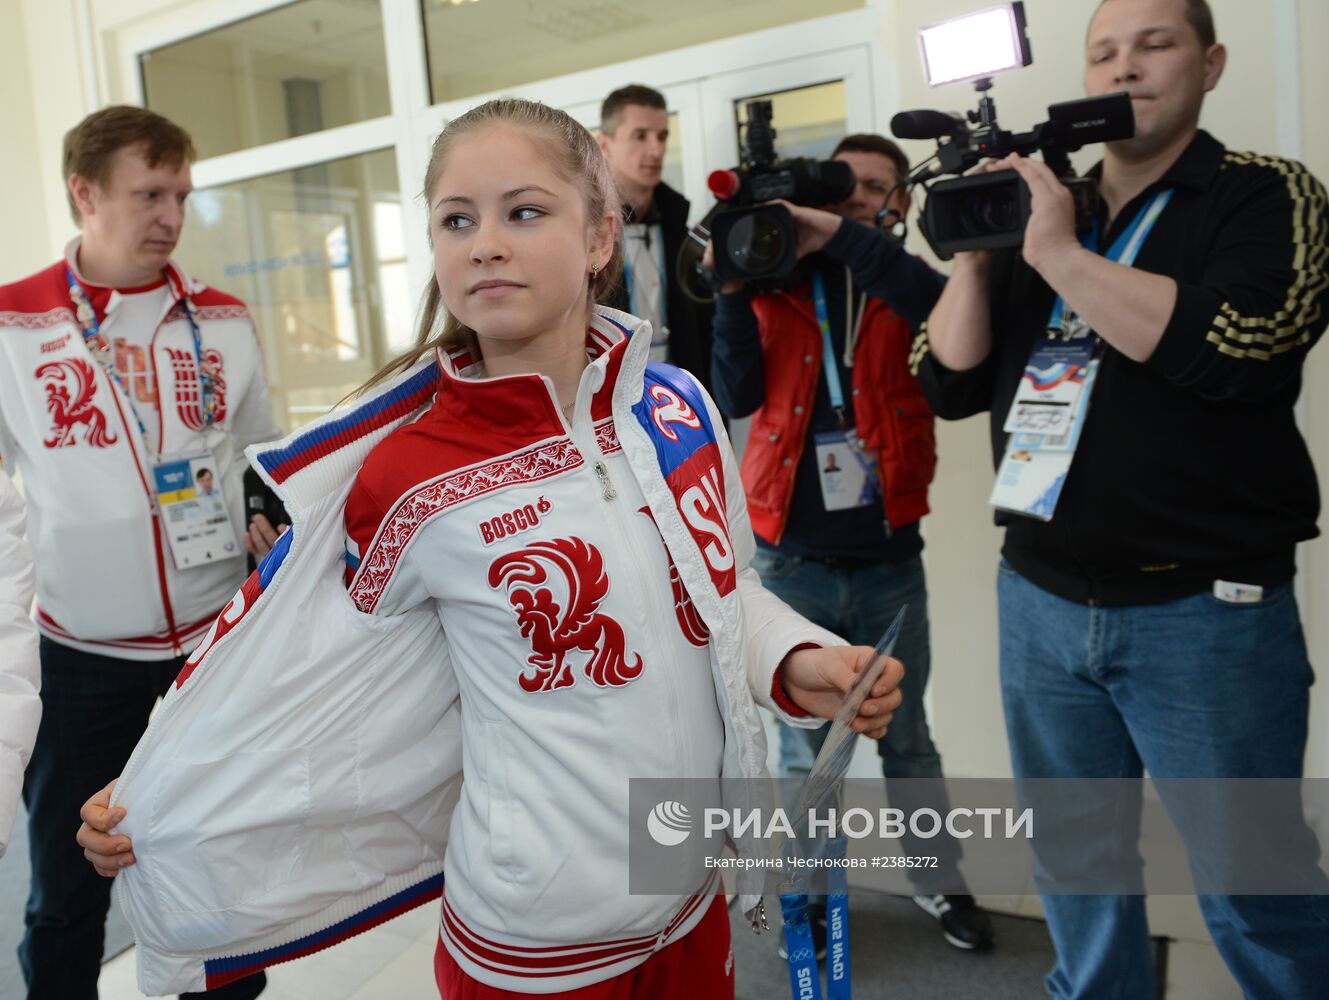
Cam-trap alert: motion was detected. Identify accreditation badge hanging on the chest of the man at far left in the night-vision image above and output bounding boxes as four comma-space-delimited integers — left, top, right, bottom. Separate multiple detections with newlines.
153, 452, 243, 570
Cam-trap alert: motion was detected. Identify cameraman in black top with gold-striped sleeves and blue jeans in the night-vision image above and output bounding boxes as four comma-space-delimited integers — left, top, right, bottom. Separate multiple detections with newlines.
913, 0, 1329, 1000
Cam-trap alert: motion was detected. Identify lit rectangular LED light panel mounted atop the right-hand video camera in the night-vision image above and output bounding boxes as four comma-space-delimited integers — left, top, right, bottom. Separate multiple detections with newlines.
918, 3, 1034, 86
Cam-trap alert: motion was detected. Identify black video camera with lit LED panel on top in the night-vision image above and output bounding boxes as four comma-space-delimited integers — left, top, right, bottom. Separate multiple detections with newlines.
890, 3, 1135, 261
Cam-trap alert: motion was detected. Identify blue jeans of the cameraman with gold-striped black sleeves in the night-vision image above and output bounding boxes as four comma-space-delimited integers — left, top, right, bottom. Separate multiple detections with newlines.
997, 561, 1329, 1000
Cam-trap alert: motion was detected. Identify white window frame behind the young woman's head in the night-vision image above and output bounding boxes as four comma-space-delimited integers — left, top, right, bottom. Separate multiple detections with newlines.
112, 0, 898, 428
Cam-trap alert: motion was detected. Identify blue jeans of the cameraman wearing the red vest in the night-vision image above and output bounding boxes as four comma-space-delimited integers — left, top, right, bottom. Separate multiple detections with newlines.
752, 548, 962, 892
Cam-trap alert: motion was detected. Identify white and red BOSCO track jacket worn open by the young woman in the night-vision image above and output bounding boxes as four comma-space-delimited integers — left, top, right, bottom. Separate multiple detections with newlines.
114, 310, 841, 993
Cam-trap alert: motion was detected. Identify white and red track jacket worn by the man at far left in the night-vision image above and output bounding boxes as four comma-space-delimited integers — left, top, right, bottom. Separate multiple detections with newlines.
0, 239, 276, 660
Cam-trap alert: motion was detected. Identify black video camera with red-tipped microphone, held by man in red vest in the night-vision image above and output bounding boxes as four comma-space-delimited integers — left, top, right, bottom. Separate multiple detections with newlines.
703, 101, 856, 282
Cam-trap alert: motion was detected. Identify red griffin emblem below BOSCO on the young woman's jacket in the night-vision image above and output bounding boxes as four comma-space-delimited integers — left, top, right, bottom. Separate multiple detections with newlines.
489, 539, 642, 691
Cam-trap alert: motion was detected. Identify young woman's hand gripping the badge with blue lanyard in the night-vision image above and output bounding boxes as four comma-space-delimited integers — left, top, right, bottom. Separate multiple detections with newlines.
777, 646, 905, 739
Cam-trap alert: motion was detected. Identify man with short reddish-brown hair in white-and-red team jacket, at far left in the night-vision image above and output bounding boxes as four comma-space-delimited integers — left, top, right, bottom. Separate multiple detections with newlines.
0, 106, 276, 1000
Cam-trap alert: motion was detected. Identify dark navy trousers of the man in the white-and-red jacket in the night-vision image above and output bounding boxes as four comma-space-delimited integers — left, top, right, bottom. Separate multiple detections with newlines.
19, 638, 266, 1000
